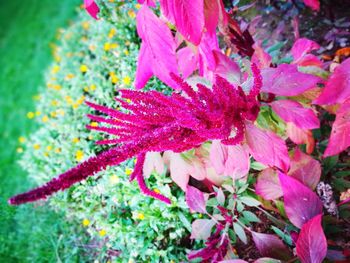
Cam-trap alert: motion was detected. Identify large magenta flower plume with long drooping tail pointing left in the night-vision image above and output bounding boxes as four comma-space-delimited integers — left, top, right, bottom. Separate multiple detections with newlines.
9, 64, 262, 205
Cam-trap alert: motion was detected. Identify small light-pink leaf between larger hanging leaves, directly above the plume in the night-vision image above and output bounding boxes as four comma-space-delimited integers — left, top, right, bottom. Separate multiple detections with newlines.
177, 47, 198, 79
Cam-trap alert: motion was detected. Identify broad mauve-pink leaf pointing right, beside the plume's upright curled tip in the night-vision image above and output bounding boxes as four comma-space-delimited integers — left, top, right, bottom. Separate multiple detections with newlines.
262, 64, 320, 96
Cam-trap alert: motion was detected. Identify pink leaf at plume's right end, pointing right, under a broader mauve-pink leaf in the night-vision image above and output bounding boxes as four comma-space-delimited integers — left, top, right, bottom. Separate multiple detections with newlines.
270, 100, 320, 129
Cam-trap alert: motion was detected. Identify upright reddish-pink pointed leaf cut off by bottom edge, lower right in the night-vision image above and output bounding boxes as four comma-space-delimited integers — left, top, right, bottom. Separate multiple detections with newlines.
296, 214, 327, 263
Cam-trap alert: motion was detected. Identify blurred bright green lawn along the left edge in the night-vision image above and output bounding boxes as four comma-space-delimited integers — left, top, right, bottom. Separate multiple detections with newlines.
0, 0, 82, 262
